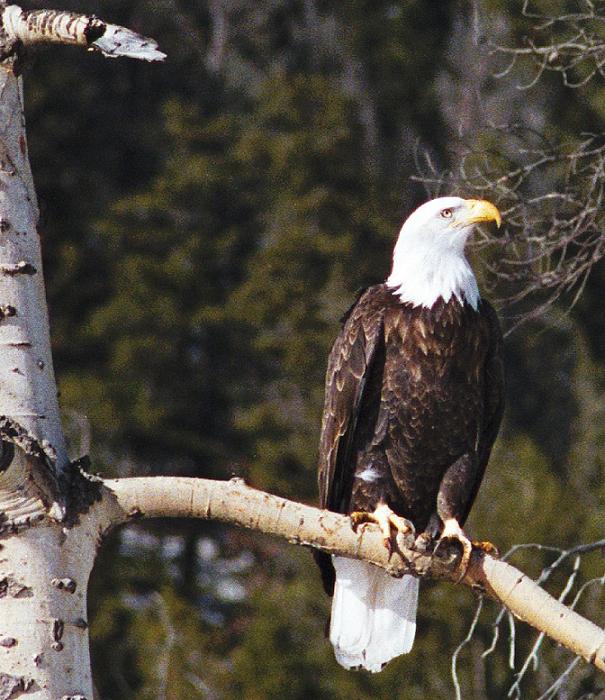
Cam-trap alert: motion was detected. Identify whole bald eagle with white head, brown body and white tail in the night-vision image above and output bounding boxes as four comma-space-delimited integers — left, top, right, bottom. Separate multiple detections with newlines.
316, 197, 504, 672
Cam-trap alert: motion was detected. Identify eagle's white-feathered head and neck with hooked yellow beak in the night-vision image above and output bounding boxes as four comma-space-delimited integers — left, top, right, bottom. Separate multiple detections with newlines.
387, 197, 501, 309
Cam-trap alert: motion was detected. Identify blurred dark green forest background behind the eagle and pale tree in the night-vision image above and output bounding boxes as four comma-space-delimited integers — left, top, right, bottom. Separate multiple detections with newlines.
25, 0, 605, 700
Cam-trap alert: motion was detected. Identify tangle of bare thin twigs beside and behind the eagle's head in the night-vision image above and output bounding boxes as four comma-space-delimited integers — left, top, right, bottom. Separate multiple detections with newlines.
414, 125, 605, 327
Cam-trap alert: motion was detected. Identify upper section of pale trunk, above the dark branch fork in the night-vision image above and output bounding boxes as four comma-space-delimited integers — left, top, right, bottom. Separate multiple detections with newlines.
0, 71, 67, 468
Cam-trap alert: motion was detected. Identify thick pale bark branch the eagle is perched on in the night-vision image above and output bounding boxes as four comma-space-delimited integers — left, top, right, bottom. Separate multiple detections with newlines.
104, 477, 605, 671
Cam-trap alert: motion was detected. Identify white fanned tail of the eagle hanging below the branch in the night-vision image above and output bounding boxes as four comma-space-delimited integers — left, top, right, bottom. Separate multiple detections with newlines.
330, 557, 418, 673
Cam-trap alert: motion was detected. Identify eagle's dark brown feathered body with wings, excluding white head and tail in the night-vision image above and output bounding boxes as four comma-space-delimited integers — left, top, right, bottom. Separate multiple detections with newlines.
318, 284, 503, 592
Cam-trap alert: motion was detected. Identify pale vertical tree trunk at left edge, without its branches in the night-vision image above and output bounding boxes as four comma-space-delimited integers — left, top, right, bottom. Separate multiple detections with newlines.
0, 63, 97, 700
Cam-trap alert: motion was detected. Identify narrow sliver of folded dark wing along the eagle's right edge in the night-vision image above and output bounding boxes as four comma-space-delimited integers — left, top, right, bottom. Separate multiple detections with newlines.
461, 299, 505, 524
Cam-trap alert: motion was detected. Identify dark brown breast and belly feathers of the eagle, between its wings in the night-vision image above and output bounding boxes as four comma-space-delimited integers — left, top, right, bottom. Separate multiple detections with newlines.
358, 295, 488, 529
